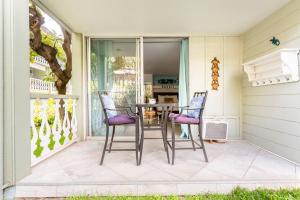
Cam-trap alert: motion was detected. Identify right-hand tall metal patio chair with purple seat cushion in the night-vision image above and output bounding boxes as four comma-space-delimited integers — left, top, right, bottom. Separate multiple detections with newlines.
168, 91, 208, 165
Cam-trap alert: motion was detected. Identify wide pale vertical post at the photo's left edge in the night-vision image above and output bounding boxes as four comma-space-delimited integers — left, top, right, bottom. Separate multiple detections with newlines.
1, 0, 31, 187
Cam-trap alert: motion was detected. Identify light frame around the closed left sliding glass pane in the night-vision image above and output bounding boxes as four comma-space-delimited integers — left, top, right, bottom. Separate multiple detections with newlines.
85, 36, 144, 137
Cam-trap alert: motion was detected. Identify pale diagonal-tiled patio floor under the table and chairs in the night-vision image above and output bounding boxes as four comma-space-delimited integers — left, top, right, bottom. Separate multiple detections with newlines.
16, 136, 300, 197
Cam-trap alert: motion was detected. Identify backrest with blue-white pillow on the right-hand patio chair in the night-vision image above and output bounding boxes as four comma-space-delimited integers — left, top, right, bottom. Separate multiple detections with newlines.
188, 91, 208, 118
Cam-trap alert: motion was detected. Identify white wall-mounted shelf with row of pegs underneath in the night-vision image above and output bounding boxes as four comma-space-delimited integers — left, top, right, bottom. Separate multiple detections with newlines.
244, 49, 299, 86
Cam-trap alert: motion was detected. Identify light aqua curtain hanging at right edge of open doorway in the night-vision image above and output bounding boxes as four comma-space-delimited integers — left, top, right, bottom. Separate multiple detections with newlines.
179, 39, 189, 138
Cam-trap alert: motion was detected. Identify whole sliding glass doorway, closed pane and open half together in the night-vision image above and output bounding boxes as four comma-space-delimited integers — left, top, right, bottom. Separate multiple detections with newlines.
87, 37, 188, 136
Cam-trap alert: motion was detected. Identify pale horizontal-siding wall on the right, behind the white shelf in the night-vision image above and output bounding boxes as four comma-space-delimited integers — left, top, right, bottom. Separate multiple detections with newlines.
242, 0, 300, 163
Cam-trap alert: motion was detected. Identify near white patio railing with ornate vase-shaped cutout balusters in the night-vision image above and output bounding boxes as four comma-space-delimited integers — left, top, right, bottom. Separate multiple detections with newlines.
30, 94, 78, 165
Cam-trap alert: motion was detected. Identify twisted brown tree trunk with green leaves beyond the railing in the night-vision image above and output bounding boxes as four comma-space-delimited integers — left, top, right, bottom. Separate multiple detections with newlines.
29, 4, 72, 94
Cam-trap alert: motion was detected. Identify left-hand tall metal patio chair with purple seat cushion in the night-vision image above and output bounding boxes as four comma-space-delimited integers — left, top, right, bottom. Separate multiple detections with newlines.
98, 92, 139, 165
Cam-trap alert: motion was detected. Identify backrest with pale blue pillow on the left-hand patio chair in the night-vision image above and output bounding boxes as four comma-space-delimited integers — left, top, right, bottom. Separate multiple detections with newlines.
98, 91, 118, 119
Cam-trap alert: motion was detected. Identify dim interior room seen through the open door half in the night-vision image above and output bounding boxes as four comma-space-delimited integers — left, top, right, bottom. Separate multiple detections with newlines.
143, 37, 183, 132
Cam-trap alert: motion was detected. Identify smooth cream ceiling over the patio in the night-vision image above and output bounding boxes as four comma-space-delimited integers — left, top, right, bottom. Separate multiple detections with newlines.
40, 0, 289, 36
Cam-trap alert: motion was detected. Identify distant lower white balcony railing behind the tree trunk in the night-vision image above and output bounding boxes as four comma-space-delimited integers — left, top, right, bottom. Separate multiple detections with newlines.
30, 78, 72, 94
